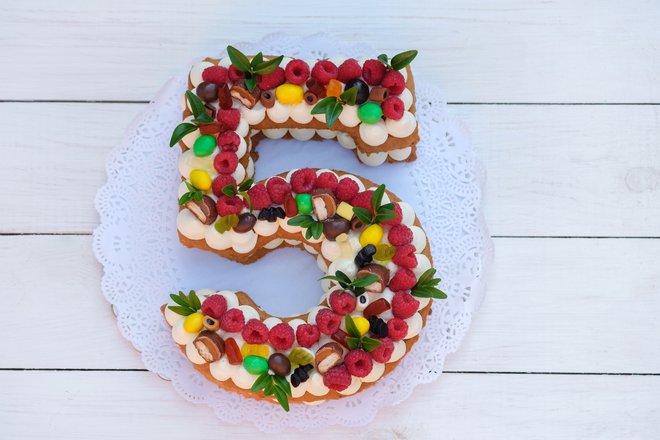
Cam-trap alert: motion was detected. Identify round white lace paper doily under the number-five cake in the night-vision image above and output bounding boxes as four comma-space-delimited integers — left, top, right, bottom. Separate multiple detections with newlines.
94, 34, 493, 431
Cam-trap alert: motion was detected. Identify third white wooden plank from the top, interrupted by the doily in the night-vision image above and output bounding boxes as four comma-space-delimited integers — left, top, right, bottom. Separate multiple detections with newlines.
0, 236, 660, 374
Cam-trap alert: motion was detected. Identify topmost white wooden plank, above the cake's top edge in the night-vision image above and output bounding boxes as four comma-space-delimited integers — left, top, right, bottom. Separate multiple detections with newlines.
0, 0, 660, 102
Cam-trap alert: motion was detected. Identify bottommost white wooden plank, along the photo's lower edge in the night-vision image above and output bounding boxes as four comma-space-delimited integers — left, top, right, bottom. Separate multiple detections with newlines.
0, 371, 660, 440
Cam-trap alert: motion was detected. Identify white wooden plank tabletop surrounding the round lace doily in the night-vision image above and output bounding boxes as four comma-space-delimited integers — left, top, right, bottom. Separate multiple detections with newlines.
0, 0, 660, 439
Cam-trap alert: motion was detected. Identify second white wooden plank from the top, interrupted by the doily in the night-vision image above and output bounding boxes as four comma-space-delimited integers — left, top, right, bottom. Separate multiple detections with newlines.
0, 103, 660, 236
